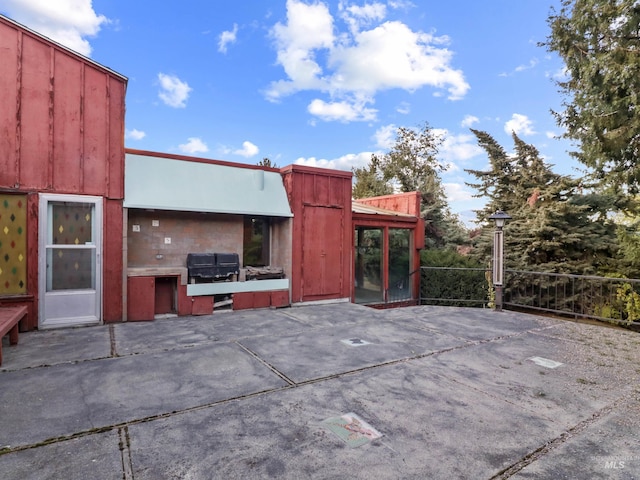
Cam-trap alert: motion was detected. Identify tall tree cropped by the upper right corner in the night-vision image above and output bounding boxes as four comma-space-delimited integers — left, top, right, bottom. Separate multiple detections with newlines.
544, 0, 640, 193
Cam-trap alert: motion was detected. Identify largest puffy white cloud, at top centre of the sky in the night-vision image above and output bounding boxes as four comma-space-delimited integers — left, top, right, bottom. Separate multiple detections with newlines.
265, 0, 469, 121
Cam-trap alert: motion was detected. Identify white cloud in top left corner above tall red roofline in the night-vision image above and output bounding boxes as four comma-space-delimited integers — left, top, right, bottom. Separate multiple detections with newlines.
1, 0, 109, 56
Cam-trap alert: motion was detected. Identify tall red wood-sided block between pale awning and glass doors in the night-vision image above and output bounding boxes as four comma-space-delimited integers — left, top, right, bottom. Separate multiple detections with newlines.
281, 165, 353, 303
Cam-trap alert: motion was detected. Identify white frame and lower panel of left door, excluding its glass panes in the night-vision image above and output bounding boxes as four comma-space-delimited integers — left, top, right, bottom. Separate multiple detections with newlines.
38, 193, 103, 329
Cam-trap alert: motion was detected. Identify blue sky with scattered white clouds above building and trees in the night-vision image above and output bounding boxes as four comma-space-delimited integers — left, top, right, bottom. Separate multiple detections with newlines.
0, 0, 568, 225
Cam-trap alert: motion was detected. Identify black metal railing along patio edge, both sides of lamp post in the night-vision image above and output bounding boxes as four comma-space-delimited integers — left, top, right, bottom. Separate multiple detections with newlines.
420, 267, 640, 325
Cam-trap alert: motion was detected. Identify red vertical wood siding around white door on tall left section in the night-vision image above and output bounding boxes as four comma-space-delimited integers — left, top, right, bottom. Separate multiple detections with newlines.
0, 18, 127, 329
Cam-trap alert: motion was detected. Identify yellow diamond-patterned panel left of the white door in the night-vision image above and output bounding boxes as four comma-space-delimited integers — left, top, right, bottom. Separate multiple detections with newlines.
0, 193, 27, 295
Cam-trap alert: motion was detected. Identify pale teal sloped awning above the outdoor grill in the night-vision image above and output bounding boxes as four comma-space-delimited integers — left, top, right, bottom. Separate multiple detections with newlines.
124, 153, 293, 217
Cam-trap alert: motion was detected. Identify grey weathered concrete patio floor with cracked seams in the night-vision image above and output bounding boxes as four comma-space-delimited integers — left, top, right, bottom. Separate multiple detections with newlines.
0, 303, 640, 480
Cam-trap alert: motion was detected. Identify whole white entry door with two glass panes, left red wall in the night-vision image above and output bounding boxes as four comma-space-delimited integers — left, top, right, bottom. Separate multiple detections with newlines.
38, 194, 102, 328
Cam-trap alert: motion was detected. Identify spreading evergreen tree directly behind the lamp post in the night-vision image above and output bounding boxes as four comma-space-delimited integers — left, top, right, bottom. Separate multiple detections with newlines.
467, 130, 617, 274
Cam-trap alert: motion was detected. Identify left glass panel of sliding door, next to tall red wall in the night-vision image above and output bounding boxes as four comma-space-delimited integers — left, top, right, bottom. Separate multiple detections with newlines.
355, 227, 384, 303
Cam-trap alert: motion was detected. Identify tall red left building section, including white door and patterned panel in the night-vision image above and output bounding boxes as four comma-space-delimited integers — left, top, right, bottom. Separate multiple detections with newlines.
0, 16, 127, 329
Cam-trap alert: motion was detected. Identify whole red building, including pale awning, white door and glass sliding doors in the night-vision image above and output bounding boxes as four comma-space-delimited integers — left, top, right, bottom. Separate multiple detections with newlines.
0, 16, 424, 330
